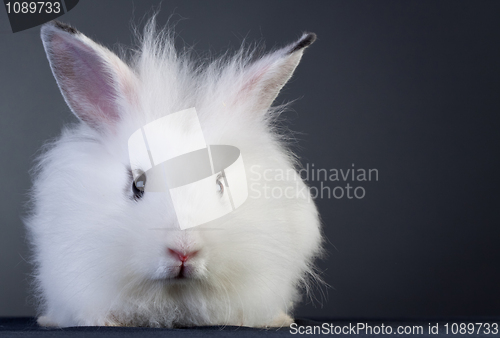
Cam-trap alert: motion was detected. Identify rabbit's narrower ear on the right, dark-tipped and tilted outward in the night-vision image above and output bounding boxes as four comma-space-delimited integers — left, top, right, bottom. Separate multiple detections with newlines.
237, 33, 316, 110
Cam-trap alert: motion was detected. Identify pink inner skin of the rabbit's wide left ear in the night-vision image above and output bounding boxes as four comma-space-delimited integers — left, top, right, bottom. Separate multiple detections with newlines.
51, 34, 120, 129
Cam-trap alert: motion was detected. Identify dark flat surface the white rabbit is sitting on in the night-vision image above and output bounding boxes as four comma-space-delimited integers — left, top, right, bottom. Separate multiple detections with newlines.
0, 317, 500, 337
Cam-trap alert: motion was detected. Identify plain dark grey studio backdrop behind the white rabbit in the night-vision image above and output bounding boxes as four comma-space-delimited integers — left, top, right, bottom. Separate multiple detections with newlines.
0, 0, 500, 318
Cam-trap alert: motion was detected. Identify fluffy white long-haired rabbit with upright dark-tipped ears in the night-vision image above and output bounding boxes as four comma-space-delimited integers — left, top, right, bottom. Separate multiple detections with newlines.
25, 20, 322, 327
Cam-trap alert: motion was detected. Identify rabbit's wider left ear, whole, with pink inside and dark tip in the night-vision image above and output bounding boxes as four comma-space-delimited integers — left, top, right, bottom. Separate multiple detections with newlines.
41, 21, 135, 131
